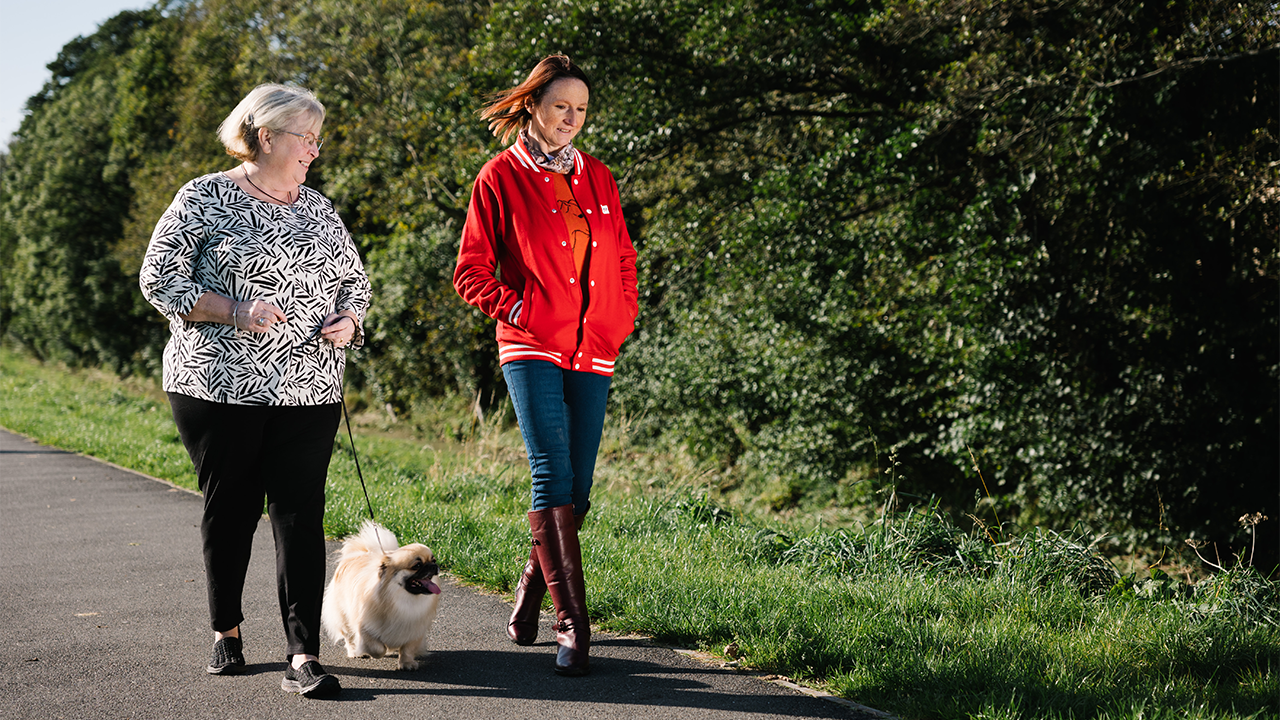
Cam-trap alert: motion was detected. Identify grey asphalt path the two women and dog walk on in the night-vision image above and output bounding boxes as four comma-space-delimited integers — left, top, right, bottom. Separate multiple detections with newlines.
0, 429, 874, 720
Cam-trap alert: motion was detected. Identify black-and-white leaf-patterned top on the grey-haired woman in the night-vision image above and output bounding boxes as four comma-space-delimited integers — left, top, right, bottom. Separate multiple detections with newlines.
138, 173, 370, 405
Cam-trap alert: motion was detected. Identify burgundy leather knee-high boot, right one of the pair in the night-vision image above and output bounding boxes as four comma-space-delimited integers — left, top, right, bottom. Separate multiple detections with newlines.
529, 505, 591, 675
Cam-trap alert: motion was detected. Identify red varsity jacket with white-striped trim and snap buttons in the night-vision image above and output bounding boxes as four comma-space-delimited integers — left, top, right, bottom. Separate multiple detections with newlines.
453, 140, 640, 375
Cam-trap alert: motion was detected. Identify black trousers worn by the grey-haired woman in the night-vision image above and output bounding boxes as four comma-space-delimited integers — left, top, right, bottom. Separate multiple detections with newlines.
169, 392, 342, 655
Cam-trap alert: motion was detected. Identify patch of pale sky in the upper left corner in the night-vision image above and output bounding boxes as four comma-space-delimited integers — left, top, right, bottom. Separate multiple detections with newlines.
0, 0, 154, 147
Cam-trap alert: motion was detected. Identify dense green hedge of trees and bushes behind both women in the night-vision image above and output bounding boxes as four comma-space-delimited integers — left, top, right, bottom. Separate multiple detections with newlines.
0, 0, 1280, 558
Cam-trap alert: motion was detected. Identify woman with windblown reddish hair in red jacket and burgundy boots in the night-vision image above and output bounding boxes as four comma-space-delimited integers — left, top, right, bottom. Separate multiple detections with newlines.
453, 55, 639, 675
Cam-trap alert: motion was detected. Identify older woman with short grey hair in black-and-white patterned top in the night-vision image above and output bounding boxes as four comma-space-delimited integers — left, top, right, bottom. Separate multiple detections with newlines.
140, 85, 370, 697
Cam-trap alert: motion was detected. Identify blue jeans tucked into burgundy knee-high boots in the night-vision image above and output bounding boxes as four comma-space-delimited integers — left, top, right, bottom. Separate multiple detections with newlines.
502, 360, 612, 515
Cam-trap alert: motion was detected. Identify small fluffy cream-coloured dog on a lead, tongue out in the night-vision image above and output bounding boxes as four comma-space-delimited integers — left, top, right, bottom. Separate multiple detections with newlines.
320, 520, 440, 670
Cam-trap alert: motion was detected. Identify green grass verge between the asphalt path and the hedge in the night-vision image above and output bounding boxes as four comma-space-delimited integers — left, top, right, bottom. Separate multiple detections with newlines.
0, 343, 1280, 720
